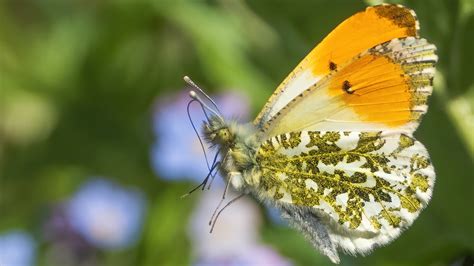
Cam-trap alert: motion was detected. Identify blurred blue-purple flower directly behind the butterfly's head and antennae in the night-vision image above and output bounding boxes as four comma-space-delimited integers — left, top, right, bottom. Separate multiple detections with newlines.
151, 90, 249, 182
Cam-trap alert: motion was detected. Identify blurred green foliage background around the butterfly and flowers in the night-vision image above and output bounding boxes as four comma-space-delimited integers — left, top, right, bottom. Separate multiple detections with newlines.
0, 0, 474, 265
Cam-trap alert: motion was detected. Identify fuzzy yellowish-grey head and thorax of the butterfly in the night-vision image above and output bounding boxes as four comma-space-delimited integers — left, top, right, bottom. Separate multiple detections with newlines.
203, 116, 260, 193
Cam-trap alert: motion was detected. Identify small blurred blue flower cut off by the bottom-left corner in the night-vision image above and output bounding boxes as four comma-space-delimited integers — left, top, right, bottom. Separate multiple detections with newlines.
0, 231, 36, 266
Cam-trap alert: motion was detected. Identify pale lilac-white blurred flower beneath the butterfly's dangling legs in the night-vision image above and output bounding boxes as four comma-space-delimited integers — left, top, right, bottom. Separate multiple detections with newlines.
189, 190, 291, 266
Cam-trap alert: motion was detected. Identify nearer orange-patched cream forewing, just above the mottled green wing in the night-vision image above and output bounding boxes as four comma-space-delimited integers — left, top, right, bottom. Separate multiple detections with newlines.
263, 37, 437, 136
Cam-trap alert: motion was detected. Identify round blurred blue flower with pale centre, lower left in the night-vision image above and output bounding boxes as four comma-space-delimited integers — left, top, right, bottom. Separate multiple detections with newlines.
67, 179, 145, 249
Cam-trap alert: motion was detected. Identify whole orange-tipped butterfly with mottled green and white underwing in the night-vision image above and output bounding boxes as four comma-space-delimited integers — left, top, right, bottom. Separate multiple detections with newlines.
187, 4, 437, 263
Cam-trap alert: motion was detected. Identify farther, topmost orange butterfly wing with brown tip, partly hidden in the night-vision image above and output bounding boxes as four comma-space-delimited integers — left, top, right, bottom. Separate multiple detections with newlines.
254, 4, 419, 126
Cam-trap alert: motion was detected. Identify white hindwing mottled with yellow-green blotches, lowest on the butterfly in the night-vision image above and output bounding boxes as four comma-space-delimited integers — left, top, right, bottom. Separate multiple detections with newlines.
256, 131, 435, 253
